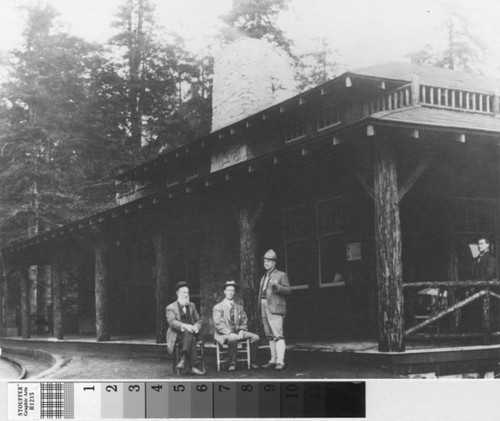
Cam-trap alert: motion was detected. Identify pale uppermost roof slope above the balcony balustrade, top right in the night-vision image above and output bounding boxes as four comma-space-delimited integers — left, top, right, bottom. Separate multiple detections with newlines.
350, 62, 500, 92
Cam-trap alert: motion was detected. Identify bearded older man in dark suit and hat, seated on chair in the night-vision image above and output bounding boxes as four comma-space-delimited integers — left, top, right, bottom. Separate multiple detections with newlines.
167, 282, 205, 375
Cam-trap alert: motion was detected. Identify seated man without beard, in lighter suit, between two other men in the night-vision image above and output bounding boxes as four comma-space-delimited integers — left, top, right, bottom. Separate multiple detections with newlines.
213, 281, 260, 371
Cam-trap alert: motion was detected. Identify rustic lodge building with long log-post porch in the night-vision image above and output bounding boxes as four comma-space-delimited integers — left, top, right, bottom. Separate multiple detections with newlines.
0, 41, 500, 352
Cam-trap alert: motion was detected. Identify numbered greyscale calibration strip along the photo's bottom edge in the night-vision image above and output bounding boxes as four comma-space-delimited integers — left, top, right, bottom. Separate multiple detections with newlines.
0, 379, 500, 421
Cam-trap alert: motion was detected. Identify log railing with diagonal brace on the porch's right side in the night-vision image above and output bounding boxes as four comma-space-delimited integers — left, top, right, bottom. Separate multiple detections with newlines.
403, 280, 500, 344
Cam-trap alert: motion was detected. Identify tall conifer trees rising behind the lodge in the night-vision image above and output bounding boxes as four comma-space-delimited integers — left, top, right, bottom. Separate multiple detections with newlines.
0, 0, 484, 247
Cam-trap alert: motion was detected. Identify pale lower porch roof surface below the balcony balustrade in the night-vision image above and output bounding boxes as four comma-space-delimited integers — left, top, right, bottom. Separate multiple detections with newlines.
370, 106, 500, 133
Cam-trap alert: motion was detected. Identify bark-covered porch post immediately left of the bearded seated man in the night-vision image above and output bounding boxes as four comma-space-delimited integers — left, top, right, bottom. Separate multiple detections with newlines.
153, 232, 168, 343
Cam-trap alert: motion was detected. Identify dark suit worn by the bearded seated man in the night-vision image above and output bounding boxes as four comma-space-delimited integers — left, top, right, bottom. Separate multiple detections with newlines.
167, 301, 201, 366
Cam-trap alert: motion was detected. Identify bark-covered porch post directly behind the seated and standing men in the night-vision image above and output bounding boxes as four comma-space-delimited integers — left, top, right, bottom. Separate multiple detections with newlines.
238, 202, 263, 332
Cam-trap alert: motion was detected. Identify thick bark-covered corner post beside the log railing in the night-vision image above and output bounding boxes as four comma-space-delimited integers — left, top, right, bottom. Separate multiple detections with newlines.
374, 139, 404, 352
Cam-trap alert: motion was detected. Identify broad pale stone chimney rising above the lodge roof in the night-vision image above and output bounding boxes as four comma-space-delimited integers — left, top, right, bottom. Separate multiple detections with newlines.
212, 37, 297, 131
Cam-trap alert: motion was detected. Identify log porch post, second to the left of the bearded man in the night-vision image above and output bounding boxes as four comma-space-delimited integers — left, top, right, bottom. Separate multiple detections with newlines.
94, 239, 110, 341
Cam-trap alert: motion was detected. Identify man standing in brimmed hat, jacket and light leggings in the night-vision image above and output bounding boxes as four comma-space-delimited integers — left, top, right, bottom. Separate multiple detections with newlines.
259, 250, 291, 370
